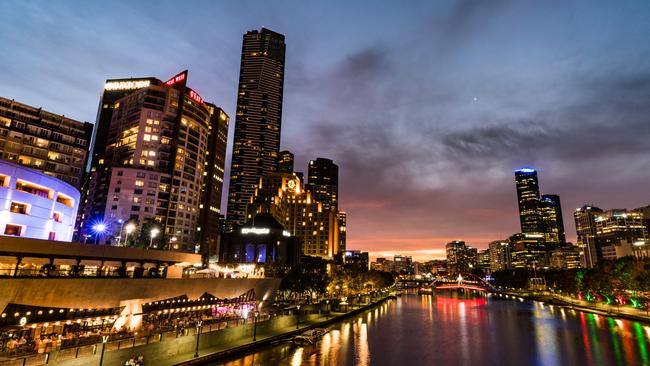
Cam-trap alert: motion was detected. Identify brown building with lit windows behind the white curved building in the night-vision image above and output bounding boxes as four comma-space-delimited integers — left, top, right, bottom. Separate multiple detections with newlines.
0, 97, 93, 189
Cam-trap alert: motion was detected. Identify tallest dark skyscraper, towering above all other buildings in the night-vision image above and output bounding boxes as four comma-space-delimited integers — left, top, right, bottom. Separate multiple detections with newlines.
228, 28, 285, 225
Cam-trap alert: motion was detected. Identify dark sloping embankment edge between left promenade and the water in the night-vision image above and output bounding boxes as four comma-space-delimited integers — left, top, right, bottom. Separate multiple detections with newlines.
169, 296, 391, 366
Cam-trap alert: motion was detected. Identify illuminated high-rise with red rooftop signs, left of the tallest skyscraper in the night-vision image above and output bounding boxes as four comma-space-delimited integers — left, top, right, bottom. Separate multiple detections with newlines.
79, 71, 228, 251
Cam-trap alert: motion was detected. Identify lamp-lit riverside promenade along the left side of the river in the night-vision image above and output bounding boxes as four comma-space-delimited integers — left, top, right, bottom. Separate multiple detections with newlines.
0, 295, 388, 366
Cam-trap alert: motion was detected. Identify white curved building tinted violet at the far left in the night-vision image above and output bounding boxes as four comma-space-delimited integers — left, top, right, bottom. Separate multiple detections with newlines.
0, 161, 80, 241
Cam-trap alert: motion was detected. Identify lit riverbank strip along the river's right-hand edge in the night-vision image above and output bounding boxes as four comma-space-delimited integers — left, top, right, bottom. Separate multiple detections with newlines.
501, 291, 650, 324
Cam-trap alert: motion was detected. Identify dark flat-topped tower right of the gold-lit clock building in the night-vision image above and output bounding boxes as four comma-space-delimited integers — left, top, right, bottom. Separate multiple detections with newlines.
307, 158, 339, 211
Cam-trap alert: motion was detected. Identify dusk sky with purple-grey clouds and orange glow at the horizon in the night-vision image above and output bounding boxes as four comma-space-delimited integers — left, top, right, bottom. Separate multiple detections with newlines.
0, 0, 650, 259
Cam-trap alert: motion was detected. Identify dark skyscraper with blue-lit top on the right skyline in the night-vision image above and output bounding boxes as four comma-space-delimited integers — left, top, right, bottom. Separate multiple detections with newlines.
515, 168, 542, 233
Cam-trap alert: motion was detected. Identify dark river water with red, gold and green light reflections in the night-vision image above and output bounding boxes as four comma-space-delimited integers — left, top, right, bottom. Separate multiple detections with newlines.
211, 294, 650, 366
